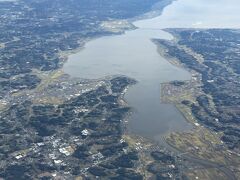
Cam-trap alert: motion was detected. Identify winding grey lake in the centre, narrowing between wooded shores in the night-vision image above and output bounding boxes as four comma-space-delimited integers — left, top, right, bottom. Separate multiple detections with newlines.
64, 29, 190, 137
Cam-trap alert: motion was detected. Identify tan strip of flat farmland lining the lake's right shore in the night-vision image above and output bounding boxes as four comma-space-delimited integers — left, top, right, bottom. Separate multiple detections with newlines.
155, 30, 239, 179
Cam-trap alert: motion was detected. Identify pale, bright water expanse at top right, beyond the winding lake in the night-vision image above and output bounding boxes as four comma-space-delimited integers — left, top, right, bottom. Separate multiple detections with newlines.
136, 0, 240, 28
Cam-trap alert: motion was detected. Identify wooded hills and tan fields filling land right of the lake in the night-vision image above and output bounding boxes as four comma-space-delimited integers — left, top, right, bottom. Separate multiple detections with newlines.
158, 29, 240, 179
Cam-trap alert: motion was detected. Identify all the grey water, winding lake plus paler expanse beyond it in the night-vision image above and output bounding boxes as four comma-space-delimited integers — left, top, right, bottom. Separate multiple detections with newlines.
64, 0, 240, 139
